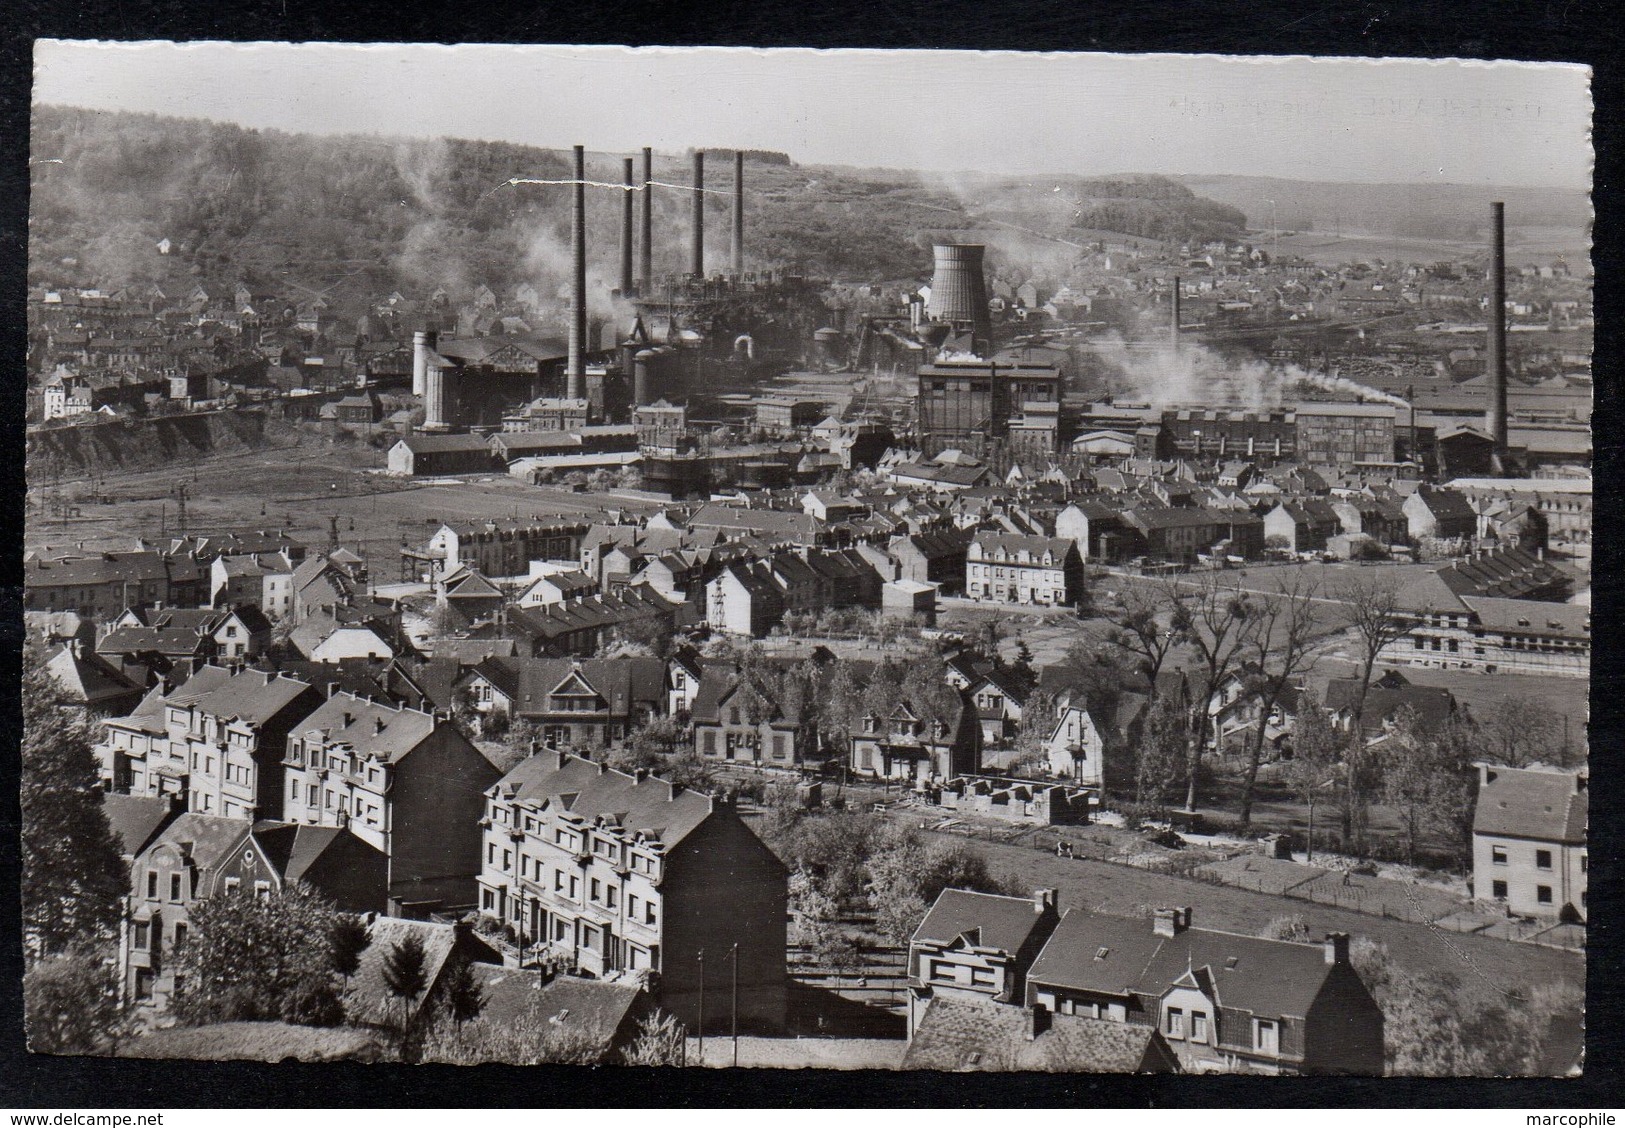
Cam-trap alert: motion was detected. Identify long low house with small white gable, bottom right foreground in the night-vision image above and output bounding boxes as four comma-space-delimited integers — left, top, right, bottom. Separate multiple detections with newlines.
1025, 909, 1383, 1076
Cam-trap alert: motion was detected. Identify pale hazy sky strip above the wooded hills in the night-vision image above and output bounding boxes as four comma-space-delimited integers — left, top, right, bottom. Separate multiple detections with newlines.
34, 41, 1591, 189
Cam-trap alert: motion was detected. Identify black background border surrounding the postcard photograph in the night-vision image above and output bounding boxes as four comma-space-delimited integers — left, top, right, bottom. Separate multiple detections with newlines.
0, 0, 1625, 1112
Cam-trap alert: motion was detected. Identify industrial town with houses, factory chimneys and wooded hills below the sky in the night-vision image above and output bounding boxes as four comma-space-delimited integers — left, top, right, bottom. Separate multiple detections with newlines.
21, 47, 1593, 1076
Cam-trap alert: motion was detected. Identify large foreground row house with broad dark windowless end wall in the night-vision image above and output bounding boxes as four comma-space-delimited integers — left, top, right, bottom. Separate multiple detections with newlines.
479, 751, 788, 1034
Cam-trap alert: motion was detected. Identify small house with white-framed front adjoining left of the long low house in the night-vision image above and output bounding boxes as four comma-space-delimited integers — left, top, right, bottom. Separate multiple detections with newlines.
908, 889, 1061, 1037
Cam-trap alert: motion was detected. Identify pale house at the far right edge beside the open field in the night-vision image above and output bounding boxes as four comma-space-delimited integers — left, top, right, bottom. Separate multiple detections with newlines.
1472, 764, 1591, 922
